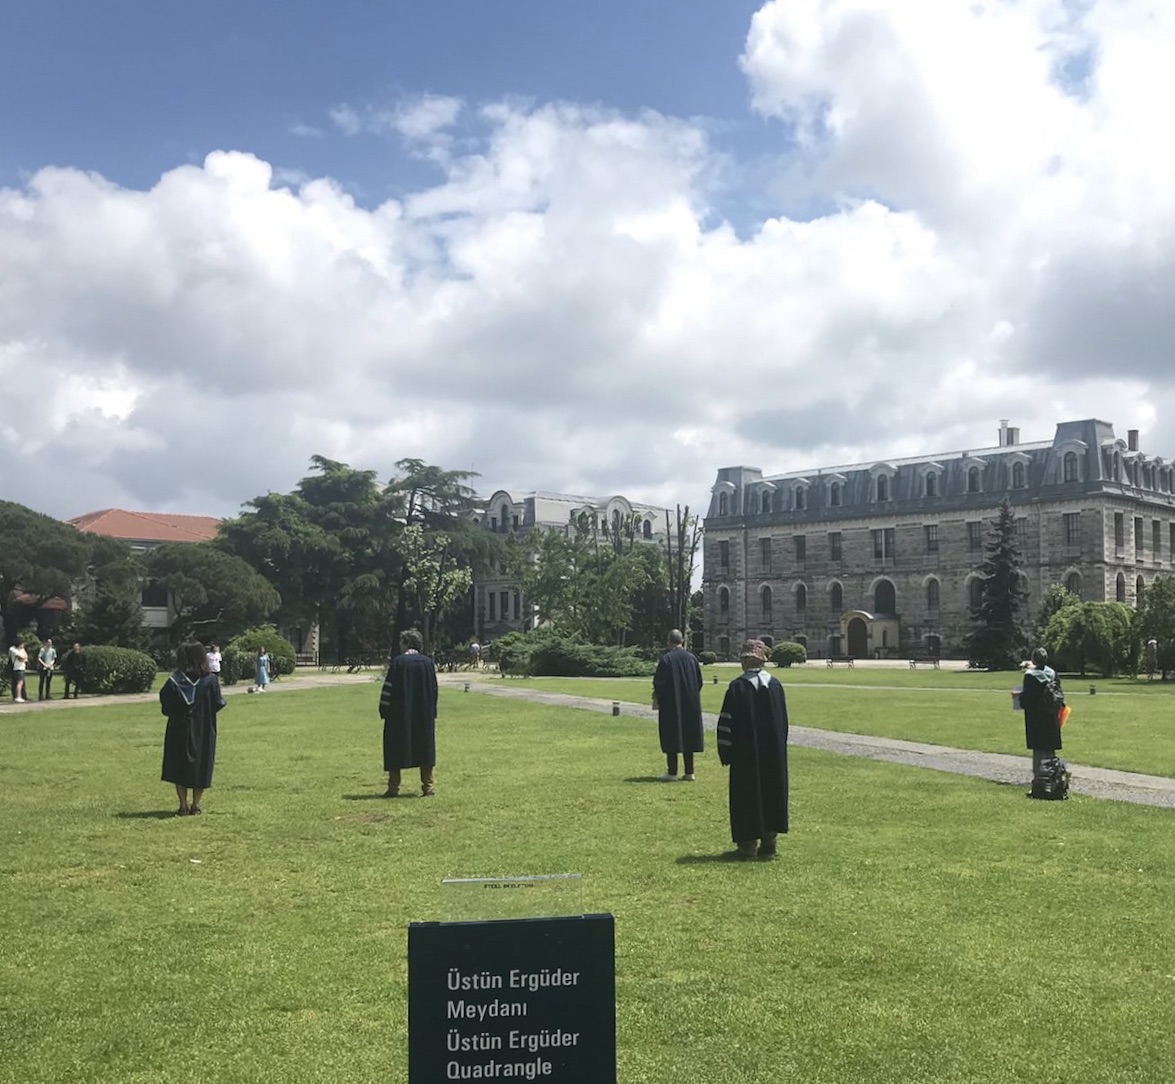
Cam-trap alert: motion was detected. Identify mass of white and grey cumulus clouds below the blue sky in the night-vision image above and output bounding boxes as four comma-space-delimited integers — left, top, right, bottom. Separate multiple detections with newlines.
0, 0, 1175, 514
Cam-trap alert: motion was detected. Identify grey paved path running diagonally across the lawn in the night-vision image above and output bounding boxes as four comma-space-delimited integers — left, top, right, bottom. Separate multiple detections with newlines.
442, 674, 1175, 808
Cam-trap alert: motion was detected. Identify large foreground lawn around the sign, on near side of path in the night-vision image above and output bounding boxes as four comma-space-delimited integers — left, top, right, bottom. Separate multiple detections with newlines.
0, 684, 1175, 1084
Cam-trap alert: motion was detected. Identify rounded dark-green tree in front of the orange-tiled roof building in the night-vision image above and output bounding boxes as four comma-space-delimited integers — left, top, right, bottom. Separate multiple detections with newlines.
146, 543, 282, 644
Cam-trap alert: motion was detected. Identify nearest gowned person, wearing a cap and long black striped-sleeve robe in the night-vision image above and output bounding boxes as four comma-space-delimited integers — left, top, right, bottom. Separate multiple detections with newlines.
718, 640, 787, 859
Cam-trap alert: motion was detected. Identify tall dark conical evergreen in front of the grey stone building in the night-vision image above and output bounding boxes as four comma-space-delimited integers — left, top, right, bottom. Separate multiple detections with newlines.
964, 500, 1027, 669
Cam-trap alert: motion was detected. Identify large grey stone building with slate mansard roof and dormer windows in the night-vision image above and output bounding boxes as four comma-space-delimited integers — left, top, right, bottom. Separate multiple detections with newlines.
703, 418, 1175, 658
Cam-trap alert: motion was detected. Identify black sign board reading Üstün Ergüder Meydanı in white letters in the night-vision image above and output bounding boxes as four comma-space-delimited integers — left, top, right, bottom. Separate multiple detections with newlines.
408, 915, 616, 1084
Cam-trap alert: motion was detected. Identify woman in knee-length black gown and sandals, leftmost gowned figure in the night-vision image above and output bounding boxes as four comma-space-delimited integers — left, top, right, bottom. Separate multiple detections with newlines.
159, 640, 224, 816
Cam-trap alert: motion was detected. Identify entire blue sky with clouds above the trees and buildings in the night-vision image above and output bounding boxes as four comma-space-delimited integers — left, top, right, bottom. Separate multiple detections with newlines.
0, 0, 1175, 516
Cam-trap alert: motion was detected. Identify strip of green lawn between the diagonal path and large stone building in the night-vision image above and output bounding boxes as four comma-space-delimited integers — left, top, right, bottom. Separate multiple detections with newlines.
517, 667, 1175, 776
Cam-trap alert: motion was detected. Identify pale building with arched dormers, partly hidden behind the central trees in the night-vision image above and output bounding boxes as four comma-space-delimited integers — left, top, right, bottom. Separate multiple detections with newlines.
474, 490, 665, 641
